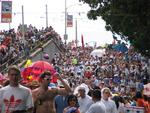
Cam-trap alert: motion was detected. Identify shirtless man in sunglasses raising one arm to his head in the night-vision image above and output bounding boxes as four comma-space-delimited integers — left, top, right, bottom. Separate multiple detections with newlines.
32, 71, 71, 113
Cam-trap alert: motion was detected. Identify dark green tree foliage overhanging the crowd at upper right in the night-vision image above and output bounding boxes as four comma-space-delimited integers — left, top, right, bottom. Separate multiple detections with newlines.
80, 0, 150, 56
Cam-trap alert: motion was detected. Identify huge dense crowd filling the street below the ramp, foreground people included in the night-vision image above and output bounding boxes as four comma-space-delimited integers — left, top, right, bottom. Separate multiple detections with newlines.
0, 33, 150, 113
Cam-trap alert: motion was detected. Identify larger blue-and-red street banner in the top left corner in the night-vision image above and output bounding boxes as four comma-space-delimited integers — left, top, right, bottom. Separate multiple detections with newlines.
1, 1, 12, 23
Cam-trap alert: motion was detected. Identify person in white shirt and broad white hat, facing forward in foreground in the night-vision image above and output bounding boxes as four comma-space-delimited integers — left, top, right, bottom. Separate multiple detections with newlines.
78, 86, 93, 113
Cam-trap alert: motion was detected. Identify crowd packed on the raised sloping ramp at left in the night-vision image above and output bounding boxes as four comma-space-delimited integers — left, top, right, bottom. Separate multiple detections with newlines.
0, 25, 61, 71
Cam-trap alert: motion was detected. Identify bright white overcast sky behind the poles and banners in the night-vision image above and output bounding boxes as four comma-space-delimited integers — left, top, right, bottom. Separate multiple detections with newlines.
0, 0, 113, 45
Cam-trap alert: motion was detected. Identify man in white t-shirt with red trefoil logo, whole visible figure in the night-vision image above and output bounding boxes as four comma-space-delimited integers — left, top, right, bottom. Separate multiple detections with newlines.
0, 66, 33, 113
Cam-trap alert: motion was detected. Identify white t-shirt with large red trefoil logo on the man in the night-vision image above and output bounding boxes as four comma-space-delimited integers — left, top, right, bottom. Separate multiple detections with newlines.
0, 85, 33, 113
